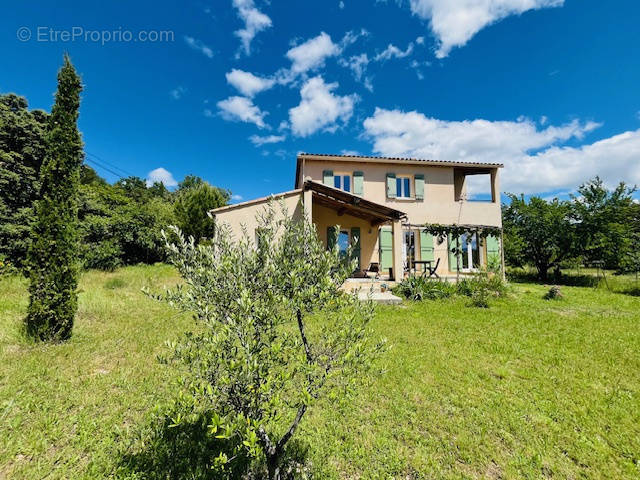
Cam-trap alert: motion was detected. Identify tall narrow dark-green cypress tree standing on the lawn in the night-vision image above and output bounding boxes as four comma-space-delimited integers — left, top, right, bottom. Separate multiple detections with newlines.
26, 55, 83, 341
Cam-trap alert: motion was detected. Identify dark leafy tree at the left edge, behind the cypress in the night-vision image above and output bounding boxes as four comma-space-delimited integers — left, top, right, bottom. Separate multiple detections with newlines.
0, 94, 48, 266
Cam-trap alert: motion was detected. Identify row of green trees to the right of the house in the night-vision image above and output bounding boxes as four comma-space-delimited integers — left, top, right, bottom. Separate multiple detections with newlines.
502, 177, 640, 280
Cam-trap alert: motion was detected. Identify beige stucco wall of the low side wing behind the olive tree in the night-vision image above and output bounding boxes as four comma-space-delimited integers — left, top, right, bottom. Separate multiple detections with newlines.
208, 191, 304, 241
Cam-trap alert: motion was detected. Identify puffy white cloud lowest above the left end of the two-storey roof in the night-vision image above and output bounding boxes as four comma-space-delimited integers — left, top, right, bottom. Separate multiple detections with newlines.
289, 76, 358, 137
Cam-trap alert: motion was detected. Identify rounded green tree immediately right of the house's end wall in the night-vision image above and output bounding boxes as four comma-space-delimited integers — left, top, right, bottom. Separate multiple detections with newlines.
503, 194, 576, 280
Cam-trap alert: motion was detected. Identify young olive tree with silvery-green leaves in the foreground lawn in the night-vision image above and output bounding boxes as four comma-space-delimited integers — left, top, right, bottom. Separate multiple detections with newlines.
152, 205, 382, 479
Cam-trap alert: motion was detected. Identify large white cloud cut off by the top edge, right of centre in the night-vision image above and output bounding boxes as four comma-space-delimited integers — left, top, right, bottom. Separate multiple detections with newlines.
410, 0, 564, 58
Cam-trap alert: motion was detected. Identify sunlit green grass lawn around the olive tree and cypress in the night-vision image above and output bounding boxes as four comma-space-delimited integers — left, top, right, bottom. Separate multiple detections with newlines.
0, 266, 640, 479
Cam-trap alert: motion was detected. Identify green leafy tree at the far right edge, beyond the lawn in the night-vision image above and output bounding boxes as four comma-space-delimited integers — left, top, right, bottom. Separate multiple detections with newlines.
572, 177, 636, 269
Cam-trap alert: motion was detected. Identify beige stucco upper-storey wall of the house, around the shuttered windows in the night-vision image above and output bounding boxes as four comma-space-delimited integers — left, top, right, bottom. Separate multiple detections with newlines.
299, 159, 502, 227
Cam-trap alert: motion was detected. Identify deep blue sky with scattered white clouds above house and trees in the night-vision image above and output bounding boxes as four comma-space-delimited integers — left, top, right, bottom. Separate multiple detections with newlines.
0, 0, 640, 201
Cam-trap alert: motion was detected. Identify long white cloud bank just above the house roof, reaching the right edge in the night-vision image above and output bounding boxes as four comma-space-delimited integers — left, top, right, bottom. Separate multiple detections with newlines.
364, 108, 640, 193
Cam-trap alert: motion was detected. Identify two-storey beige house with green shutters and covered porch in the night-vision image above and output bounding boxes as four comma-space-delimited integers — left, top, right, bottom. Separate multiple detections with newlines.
211, 153, 504, 280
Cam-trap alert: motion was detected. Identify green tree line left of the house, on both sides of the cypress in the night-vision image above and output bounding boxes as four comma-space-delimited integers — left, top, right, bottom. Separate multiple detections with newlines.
0, 94, 230, 271
